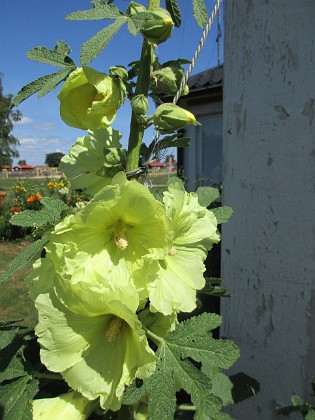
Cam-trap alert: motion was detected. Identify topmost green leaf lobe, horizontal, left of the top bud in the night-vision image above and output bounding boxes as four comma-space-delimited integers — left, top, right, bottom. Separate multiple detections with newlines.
66, 0, 123, 20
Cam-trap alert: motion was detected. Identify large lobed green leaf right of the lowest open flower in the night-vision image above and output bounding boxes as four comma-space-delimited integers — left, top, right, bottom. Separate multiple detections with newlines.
127, 313, 239, 420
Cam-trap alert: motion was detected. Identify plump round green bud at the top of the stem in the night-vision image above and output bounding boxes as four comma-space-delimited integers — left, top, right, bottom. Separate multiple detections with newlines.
141, 8, 174, 44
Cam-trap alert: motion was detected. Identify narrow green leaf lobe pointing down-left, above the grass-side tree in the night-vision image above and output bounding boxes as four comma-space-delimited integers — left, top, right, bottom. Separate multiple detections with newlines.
12, 67, 75, 106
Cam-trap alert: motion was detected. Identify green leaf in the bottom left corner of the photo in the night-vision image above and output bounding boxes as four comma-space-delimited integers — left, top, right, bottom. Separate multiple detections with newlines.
0, 377, 38, 420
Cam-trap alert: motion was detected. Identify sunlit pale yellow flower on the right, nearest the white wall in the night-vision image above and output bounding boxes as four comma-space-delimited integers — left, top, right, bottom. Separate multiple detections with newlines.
148, 182, 220, 315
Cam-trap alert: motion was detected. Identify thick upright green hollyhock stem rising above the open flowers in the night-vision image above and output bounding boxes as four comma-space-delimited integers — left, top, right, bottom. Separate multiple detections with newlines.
126, 0, 160, 172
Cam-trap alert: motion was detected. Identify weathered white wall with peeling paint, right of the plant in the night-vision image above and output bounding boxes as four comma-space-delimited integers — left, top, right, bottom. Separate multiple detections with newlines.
221, 0, 315, 420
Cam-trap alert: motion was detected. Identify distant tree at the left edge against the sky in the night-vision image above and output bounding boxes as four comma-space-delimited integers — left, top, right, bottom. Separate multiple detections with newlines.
0, 73, 22, 167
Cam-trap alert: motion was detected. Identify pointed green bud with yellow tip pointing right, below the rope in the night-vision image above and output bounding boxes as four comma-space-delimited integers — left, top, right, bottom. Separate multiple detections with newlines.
153, 103, 197, 134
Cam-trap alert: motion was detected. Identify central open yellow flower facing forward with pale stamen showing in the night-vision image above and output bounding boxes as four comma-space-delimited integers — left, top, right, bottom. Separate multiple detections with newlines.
50, 172, 172, 282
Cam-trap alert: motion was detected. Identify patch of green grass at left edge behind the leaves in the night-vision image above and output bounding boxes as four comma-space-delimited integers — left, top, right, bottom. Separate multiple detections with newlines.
0, 241, 37, 327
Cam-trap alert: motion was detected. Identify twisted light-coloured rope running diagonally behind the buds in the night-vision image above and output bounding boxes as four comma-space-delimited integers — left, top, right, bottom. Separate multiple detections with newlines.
152, 0, 222, 161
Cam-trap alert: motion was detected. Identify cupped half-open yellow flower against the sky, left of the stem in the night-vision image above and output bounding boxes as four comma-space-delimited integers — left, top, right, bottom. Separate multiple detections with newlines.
58, 66, 126, 130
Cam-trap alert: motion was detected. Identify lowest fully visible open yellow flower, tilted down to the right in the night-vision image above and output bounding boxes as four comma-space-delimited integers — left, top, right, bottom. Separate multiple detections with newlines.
35, 279, 155, 410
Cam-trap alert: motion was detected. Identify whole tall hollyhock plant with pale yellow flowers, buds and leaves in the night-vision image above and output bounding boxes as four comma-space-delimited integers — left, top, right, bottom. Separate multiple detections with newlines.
0, 0, 239, 420
